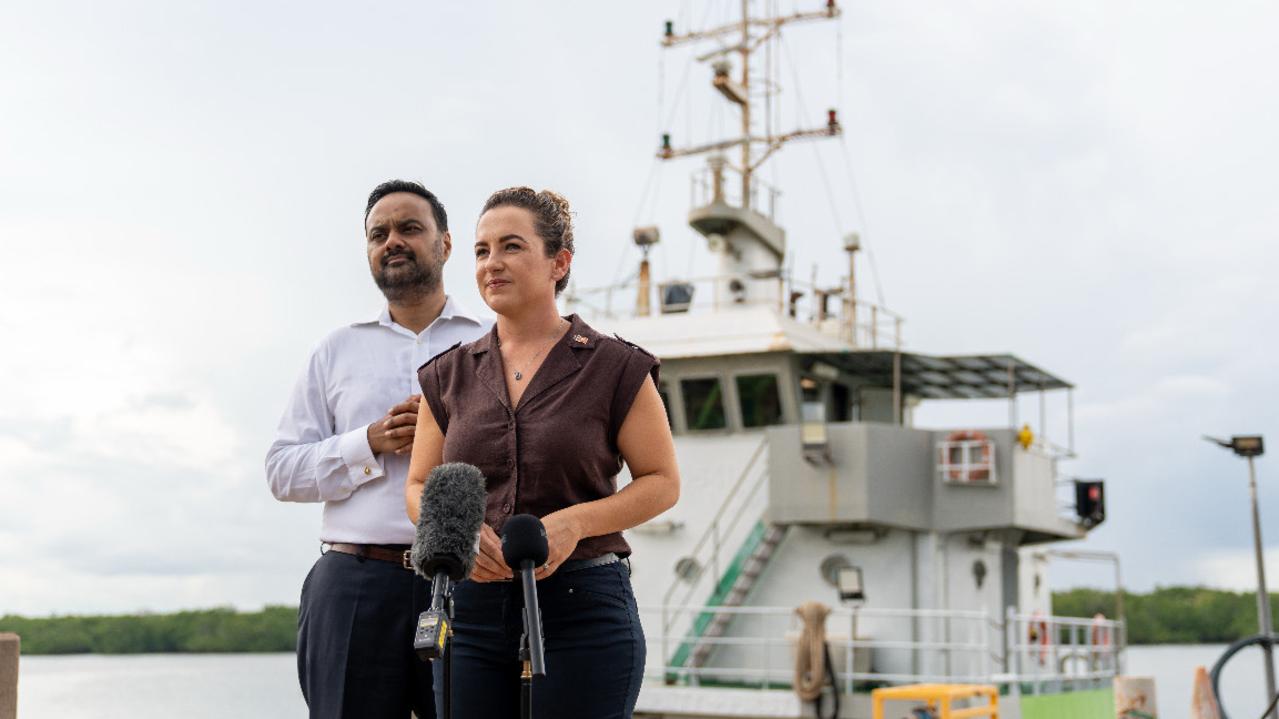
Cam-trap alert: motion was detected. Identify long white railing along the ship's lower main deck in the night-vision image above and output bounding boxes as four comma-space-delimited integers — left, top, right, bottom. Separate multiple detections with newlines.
640, 604, 1124, 693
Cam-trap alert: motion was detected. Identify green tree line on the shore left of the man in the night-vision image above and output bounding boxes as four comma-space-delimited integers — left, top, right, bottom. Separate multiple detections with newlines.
0, 606, 298, 655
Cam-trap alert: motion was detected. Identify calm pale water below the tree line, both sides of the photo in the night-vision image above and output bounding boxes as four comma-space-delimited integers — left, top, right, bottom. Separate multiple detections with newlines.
18, 646, 1279, 719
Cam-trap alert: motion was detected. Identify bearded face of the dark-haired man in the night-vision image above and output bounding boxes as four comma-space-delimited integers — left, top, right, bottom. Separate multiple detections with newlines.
365, 192, 453, 302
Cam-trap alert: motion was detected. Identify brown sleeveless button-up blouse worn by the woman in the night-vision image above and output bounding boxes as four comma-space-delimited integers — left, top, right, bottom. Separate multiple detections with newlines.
417, 315, 659, 559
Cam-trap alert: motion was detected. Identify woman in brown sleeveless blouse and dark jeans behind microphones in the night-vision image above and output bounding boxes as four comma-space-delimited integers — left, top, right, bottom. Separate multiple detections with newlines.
405, 187, 679, 719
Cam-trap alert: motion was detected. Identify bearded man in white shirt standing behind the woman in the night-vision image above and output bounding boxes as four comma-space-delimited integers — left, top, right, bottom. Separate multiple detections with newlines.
266, 180, 491, 719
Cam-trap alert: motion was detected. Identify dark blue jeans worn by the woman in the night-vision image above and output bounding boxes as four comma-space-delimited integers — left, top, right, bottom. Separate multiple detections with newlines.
434, 562, 645, 719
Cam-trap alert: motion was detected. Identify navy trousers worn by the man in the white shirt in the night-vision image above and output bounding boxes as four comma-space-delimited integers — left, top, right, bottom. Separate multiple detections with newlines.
298, 551, 435, 719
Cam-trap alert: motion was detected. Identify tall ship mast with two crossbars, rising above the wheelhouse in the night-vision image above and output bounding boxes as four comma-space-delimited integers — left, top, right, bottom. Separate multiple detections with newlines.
657, 0, 843, 311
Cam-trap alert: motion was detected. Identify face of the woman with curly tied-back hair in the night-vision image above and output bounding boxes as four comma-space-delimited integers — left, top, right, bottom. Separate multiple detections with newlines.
475, 206, 572, 315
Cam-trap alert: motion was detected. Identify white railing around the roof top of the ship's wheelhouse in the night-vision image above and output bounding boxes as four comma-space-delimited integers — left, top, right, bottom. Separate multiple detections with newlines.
564, 273, 904, 351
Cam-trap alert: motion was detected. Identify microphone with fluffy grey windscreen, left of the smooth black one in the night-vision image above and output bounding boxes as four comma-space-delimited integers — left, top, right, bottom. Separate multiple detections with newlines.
409, 462, 486, 660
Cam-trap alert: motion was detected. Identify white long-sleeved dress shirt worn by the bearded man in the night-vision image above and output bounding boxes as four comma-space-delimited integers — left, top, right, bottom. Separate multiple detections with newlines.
266, 297, 492, 544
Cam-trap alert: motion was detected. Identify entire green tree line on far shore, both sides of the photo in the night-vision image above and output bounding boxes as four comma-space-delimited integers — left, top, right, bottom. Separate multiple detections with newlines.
0, 587, 1279, 655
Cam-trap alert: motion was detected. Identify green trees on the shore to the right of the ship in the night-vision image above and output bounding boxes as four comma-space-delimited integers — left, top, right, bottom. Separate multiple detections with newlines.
1053, 587, 1279, 645
